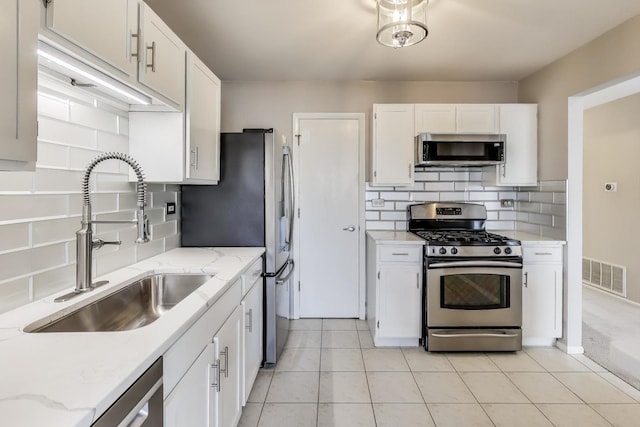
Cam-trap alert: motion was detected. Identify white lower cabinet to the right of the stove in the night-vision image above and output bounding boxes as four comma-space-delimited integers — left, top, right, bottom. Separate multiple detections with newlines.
522, 242, 563, 345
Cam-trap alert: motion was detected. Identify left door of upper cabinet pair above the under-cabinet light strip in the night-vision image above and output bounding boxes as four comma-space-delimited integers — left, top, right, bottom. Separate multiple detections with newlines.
46, 0, 139, 80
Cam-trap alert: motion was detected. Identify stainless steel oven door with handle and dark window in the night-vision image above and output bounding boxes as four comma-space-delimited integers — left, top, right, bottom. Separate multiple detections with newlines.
425, 260, 522, 328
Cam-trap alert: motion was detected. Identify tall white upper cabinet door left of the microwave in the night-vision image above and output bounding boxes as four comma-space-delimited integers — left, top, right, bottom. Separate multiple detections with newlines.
372, 104, 415, 185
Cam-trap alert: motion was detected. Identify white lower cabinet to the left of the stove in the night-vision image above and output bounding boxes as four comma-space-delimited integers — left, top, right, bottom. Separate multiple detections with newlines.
367, 236, 422, 346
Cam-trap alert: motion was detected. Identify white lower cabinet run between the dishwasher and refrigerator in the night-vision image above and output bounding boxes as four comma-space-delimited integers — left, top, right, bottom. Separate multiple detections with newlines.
163, 261, 263, 427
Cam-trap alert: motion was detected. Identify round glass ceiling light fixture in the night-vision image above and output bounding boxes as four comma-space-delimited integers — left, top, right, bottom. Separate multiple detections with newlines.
376, 0, 429, 48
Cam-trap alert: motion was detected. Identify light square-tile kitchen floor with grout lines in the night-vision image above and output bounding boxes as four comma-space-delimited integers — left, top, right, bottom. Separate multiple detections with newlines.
240, 319, 640, 427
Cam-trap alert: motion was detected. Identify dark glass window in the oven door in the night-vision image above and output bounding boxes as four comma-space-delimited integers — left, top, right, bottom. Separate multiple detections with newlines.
440, 274, 510, 310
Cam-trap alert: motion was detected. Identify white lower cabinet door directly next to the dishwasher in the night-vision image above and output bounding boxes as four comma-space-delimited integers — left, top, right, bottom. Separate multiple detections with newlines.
164, 343, 218, 427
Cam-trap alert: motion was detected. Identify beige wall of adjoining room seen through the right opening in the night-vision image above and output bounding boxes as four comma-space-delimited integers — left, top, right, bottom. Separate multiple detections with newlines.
582, 94, 640, 302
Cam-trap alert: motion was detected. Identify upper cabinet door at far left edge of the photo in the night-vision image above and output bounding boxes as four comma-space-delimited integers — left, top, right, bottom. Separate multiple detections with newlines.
0, 0, 40, 170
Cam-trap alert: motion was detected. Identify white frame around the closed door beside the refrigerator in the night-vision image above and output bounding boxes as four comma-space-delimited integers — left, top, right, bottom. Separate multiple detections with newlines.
290, 113, 366, 319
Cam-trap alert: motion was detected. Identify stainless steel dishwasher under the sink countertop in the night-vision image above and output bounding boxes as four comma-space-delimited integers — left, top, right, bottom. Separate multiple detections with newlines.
92, 357, 164, 427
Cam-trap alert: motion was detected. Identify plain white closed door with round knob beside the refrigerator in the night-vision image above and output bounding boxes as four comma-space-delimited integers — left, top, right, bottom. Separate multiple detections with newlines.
294, 114, 364, 318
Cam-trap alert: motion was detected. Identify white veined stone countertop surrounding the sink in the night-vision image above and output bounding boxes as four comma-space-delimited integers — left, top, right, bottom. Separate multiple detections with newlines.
0, 248, 264, 427
